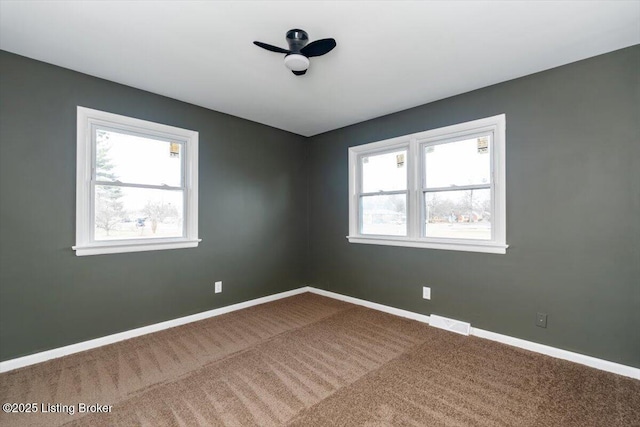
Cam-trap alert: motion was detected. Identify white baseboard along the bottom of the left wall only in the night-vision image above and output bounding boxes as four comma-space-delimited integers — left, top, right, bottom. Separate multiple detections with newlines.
0, 287, 309, 373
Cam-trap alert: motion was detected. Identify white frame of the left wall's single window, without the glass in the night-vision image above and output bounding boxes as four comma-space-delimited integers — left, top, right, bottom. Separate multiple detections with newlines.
72, 106, 201, 256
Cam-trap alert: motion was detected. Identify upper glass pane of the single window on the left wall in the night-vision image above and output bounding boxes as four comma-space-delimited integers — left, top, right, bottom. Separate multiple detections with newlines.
96, 129, 184, 187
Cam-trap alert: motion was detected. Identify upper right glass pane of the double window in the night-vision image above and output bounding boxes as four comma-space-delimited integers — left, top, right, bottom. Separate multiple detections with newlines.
424, 134, 491, 188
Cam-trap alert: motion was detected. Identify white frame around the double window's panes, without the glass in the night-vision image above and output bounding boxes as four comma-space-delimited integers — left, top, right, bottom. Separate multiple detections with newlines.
347, 114, 508, 254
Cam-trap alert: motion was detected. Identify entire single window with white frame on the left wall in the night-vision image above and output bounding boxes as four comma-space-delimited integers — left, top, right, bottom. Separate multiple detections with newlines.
73, 107, 200, 256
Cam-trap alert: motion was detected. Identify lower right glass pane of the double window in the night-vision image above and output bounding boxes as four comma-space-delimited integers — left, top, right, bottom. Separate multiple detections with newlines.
424, 189, 491, 240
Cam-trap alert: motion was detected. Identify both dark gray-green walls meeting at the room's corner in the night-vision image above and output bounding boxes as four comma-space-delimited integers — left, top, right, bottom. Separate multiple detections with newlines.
0, 46, 640, 367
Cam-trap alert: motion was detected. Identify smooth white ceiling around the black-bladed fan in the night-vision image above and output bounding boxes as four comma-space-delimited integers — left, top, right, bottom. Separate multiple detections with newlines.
0, 0, 640, 136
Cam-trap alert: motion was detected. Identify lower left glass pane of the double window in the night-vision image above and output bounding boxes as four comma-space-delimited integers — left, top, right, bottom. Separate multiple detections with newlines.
360, 194, 407, 236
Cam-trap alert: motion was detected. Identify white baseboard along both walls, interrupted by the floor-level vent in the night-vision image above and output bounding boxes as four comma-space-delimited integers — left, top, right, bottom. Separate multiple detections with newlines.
0, 286, 640, 380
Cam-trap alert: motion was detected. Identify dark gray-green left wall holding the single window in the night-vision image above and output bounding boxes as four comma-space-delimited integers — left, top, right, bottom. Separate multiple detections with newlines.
0, 52, 307, 360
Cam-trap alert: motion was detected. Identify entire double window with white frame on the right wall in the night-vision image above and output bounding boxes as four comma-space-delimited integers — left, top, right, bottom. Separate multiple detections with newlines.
347, 114, 507, 254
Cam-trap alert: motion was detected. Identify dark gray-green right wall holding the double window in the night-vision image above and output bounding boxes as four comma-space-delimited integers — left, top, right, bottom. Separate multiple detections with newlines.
309, 46, 640, 367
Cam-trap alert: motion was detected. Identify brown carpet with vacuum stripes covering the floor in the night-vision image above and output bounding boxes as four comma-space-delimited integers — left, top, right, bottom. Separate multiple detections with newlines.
0, 293, 640, 427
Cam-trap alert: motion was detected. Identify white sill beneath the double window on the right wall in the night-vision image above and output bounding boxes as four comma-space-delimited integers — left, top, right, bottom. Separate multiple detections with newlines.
347, 236, 509, 254
